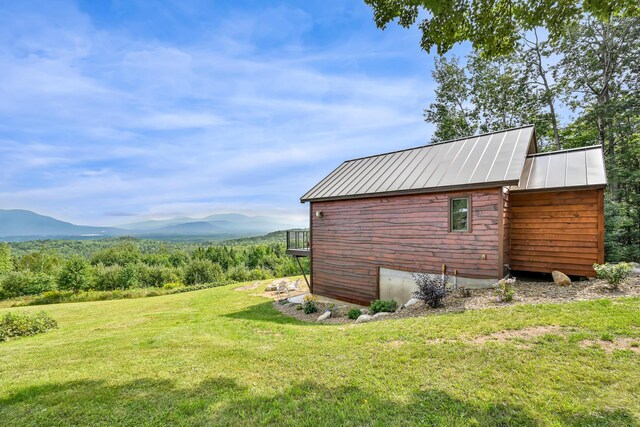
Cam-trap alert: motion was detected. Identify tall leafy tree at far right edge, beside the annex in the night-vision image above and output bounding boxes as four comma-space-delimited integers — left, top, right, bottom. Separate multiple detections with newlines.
554, 17, 640, 261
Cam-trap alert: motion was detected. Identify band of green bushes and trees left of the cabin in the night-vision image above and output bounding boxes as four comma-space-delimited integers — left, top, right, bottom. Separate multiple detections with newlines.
0, 236, 309, 299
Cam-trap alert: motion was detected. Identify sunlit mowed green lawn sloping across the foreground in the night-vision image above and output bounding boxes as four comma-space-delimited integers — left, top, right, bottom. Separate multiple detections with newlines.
0, 284, 640, 426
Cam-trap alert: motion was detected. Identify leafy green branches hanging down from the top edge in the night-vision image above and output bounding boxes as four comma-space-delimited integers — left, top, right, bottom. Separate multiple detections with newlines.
365, 0, 639, 58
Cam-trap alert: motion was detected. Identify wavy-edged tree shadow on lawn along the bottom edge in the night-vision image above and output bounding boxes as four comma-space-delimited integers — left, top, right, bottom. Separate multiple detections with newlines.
0, 377, 639, 426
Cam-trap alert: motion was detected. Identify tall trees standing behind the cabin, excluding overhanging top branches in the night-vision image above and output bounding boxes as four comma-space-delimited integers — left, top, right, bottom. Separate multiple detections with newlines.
425, 16, 640, 261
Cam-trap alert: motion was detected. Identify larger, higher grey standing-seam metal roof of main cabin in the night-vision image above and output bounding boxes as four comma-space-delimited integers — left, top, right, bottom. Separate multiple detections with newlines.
300, 125, 536, 202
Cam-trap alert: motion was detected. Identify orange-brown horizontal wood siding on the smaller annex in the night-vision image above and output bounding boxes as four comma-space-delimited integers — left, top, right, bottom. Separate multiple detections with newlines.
509, 189, 604, 277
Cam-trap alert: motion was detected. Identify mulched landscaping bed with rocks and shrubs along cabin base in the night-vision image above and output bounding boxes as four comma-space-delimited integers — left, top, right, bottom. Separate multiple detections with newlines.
274, 274, 640, 323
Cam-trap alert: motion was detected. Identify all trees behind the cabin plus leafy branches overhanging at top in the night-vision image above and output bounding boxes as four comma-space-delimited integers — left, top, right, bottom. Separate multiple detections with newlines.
364, 0, 640, 261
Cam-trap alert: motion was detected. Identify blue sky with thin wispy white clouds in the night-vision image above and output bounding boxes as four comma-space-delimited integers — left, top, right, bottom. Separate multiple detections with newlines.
0, 0, 468, 225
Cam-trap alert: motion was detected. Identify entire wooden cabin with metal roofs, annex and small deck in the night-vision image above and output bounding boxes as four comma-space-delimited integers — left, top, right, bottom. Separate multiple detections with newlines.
288, 126, 606, 304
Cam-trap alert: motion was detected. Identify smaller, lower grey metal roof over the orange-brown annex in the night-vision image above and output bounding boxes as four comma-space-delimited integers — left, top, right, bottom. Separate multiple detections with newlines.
511, 145, 607, 191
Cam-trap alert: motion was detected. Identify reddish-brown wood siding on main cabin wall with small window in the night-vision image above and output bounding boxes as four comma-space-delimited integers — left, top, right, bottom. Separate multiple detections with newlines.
311, 188, 504, 304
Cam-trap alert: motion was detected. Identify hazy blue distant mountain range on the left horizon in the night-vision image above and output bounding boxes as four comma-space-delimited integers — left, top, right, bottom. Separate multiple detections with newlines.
0, 209, 307, 241
